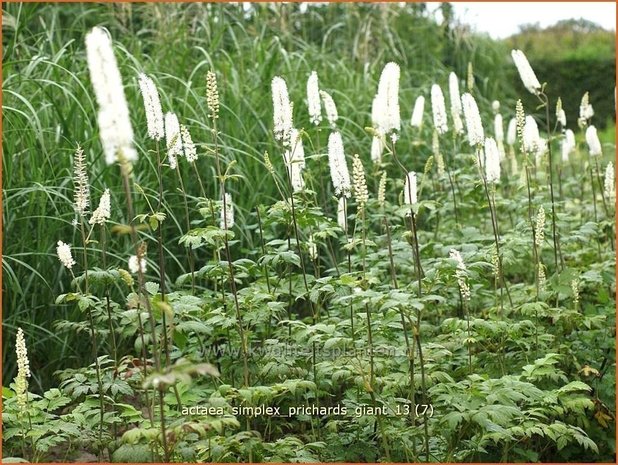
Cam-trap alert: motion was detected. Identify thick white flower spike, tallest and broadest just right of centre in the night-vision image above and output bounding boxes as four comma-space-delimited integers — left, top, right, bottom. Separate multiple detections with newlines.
371, 62, 401, 139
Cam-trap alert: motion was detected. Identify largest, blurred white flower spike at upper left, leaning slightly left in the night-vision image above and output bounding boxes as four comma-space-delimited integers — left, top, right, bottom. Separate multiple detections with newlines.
86, 27, 137, 165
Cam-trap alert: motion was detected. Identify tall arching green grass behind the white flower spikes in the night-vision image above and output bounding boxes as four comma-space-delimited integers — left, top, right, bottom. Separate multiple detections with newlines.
2, 3, 615, 391
